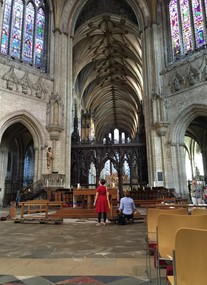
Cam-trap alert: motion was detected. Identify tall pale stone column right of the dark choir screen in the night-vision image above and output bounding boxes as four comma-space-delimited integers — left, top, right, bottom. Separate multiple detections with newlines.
142, 23, 168, 186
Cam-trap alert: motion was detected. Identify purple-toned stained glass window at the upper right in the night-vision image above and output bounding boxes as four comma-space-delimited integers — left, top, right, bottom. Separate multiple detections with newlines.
168, 0, 207, 61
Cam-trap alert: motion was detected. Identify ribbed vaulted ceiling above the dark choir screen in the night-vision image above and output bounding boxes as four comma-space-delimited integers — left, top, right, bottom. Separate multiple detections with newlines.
73, 0, 143, 139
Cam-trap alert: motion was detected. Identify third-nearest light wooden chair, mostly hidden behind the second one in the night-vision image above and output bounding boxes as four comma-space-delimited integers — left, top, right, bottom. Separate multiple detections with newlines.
146, 208, 188, 279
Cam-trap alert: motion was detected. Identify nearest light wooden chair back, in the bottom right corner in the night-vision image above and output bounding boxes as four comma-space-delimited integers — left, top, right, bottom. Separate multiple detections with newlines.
168, 228, 207, 285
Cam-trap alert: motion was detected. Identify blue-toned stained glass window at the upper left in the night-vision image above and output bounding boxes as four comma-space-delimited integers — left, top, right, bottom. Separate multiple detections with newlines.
0, 0, 46, 70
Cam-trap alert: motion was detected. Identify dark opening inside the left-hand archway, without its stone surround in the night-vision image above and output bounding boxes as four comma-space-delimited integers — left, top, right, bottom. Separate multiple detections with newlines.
1, 123, 35, 206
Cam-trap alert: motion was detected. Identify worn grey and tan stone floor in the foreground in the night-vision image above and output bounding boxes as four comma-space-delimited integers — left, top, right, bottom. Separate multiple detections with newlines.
0, 208, 162, 285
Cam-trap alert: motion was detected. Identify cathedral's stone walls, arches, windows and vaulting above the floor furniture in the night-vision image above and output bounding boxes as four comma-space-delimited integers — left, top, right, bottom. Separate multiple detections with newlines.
0, 0, 207, 205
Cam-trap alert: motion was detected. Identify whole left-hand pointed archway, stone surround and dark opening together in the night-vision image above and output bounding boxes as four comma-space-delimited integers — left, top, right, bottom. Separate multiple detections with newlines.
0, 111, 47, 205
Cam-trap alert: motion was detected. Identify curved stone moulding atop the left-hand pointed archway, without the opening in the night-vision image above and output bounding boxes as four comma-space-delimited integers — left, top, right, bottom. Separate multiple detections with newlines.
0, 110, 47, 148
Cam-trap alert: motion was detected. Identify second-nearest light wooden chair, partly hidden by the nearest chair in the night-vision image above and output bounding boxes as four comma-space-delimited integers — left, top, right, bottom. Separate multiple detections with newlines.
156, 214, 207, 285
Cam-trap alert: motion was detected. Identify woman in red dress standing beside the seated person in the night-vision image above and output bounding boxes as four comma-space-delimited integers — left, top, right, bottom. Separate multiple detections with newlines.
93, 179, 109, 226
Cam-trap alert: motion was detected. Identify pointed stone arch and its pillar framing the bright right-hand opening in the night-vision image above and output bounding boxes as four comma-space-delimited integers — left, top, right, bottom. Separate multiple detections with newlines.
168, 104, 207, 195
